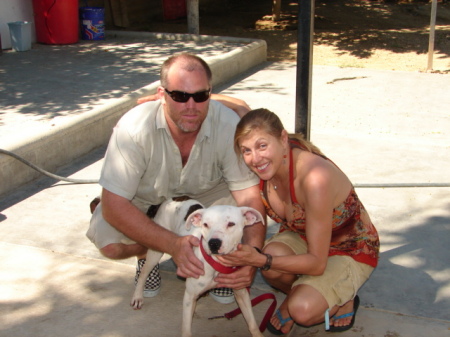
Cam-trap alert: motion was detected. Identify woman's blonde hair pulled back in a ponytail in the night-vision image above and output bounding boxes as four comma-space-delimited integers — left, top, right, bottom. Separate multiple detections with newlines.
234, 108, 323, 157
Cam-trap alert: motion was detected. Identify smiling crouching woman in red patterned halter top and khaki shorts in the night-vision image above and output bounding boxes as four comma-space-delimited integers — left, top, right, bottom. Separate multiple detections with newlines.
222, 109, 379, 334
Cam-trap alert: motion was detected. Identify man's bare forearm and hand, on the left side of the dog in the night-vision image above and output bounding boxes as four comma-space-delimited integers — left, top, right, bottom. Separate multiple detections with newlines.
102, 189, 204, 278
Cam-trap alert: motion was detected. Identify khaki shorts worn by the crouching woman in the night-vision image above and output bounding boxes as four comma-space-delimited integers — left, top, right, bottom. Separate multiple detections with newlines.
265, 231, 374, 308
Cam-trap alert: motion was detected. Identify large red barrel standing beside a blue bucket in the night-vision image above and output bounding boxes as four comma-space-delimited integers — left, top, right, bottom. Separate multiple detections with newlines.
33, 0, 80, 44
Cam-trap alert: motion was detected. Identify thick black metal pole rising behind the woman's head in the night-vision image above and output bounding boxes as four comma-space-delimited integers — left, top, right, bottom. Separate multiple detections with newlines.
295, 0, 314, 140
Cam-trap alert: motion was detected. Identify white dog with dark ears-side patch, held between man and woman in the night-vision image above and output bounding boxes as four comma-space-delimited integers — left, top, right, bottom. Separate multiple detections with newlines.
131, 199, 264, 337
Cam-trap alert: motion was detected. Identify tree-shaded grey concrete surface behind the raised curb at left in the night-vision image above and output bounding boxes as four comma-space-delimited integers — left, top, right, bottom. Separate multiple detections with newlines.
0, 37, 243, 126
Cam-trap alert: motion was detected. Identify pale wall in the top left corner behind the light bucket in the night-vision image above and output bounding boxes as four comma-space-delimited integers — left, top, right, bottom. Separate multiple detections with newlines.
0, 0, 36, 49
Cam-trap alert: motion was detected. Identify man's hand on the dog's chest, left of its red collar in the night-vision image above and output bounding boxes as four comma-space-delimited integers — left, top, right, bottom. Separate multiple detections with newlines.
171, 235, 205, 278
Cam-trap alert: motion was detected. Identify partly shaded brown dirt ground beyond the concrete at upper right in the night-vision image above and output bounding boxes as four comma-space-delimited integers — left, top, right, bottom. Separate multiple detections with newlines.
139, 0, 450, 73
